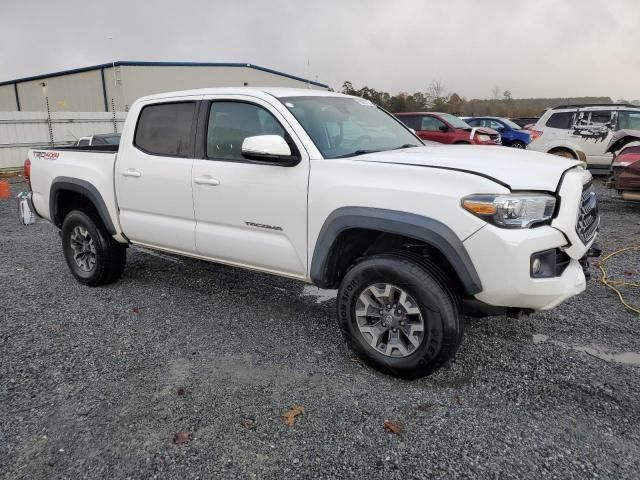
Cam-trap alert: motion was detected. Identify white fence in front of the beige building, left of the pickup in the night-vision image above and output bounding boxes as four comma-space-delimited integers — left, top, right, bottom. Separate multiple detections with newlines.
0, 112, 127, 169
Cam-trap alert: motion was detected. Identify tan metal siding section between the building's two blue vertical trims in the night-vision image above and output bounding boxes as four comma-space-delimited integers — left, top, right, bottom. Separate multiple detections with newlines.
18, 70, 104, 112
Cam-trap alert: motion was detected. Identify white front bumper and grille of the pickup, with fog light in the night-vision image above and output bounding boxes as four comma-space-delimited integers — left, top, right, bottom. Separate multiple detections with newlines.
464, 168, 600, 310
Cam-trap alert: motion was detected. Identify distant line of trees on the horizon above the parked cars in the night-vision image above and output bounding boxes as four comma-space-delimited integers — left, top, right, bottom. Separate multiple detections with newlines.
342, 80, 613, 117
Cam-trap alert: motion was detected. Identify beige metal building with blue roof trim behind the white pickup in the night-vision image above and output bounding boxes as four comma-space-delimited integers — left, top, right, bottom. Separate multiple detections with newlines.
0, 61, 329, 112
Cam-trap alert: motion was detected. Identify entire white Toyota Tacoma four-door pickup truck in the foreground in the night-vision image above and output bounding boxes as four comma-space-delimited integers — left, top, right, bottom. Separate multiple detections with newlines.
23, 88, 600, 378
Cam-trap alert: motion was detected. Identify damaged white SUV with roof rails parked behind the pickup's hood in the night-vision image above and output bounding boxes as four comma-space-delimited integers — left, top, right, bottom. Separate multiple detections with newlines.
529, 104, 640, 169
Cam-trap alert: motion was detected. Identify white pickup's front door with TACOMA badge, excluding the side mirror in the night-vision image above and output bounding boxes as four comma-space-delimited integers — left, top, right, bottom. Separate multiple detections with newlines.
193, 96, 309, 278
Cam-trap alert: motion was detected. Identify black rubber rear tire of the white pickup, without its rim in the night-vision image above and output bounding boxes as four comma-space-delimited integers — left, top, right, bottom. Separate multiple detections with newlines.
61, 210, 127, 287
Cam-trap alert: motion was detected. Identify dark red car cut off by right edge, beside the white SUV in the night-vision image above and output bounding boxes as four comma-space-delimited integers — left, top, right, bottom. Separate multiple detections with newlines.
607, 130, 640, 201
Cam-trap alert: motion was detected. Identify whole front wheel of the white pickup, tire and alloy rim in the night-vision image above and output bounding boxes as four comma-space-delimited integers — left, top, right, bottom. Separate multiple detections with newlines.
337, 254, 464, 379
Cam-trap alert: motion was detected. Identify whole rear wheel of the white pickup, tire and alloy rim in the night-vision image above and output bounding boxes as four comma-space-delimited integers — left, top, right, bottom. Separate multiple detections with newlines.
62, 210, 127, 286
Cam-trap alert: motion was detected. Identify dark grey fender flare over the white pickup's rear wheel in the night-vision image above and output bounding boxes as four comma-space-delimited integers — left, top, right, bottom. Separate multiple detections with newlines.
49, 177, 117, 235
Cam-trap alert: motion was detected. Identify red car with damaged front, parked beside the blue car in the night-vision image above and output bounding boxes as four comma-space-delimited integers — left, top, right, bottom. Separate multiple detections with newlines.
394, 112, 502, 145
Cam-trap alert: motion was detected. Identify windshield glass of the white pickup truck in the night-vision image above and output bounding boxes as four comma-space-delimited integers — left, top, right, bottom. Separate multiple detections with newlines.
280, 96, 422, 158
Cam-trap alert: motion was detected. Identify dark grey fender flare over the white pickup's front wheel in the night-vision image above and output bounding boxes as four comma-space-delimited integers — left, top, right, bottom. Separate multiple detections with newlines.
310, 207, 482, 296
